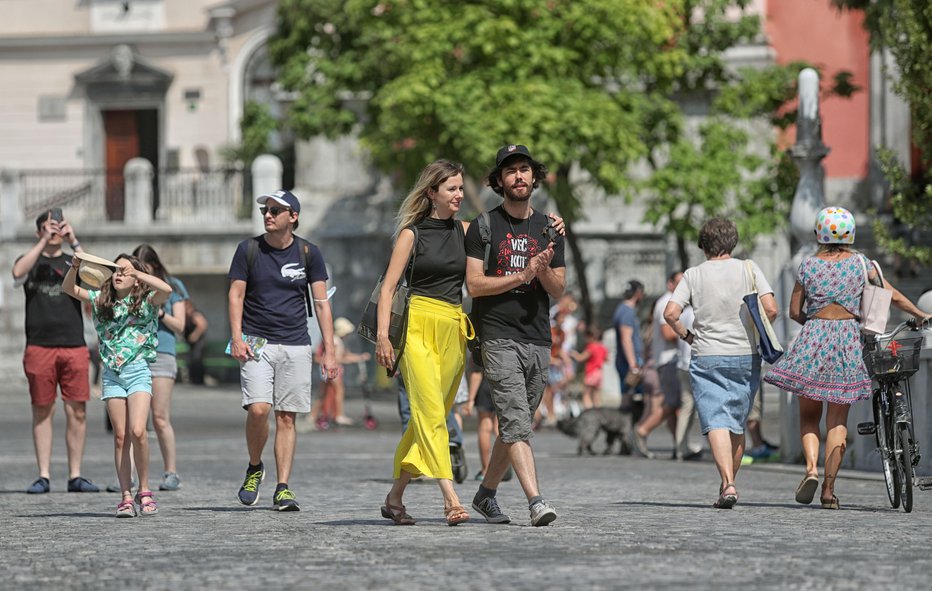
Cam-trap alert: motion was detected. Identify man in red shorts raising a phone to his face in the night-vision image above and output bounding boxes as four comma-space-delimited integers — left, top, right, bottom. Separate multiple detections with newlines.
13, 209, 98, 494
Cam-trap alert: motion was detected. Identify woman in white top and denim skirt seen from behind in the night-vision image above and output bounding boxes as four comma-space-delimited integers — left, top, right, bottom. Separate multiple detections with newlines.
663, 218, 777, 509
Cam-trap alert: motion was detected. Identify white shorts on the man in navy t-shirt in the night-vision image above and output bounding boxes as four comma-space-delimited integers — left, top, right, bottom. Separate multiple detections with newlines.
239, 344, 313, 412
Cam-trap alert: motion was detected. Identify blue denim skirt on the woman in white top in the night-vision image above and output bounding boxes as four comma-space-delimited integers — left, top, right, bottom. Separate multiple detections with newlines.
689, 355, 760, 435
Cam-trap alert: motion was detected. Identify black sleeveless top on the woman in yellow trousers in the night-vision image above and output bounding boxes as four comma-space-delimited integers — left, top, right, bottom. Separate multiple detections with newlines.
411, 218, 466, 305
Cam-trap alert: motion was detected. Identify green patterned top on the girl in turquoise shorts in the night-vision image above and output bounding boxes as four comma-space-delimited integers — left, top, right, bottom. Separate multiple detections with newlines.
88, 290, 159, 373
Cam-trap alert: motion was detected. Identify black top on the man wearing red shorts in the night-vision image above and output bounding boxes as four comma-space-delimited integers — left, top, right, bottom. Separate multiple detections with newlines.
23, 254, 86, 347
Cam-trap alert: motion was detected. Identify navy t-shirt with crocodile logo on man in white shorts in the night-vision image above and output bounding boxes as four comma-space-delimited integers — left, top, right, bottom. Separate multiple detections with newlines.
227, 235, 327, 345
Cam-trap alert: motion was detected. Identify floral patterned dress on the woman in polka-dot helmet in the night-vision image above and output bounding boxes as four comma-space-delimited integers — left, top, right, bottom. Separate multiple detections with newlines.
764, 254, 871, 404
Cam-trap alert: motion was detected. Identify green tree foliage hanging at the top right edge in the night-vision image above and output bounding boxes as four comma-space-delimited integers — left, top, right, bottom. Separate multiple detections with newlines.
832, 0, 932, 265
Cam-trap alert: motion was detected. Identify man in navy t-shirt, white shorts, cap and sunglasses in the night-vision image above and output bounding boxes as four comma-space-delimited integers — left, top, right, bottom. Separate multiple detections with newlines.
229, 190, 338, 511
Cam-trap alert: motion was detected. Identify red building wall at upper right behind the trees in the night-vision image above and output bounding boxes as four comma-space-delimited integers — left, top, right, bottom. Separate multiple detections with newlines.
764, 0, 870, 178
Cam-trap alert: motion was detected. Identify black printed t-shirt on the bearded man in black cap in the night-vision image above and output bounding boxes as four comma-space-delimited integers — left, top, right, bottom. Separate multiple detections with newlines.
466, 206, 565, 346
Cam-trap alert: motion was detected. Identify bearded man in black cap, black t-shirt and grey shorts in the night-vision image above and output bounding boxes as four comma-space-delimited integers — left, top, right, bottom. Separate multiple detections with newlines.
466, 144, 566, 526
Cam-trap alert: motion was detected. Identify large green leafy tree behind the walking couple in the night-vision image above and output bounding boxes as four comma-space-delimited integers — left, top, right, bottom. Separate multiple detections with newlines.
269, 0, 828, 319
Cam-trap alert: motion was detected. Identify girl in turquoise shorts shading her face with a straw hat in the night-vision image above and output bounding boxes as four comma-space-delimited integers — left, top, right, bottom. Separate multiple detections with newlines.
62, 254, 172, 517
